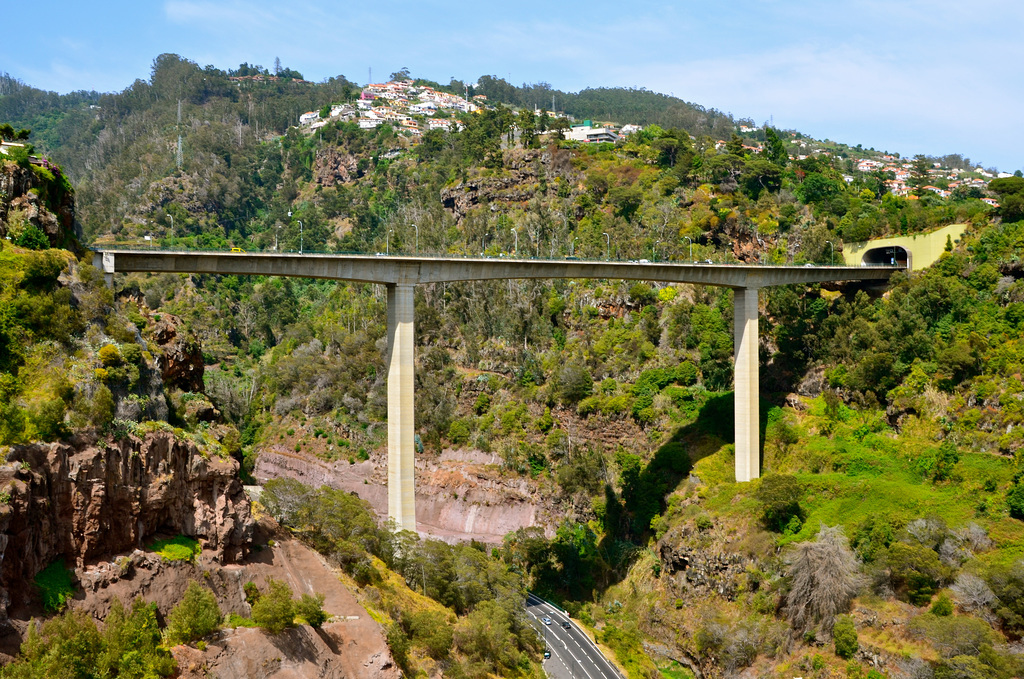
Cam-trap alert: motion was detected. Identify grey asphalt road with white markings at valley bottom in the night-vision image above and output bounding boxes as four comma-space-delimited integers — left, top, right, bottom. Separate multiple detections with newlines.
526, 594, 622, 679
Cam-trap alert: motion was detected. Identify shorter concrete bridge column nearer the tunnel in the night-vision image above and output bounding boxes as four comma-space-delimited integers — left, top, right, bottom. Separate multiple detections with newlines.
733, 288, 761, 481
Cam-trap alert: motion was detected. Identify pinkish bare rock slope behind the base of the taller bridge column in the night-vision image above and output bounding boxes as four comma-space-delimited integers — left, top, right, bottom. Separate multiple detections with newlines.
254, 447, 559, 543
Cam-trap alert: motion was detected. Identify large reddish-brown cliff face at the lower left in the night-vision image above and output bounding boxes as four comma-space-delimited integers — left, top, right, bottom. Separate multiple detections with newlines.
0, 432, 254, 622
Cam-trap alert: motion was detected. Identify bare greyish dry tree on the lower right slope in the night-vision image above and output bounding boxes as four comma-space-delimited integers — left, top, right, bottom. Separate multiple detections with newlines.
785, 524, 862, 634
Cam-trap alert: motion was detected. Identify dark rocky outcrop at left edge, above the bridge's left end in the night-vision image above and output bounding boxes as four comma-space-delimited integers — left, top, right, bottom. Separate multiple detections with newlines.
0, 157, 76, 247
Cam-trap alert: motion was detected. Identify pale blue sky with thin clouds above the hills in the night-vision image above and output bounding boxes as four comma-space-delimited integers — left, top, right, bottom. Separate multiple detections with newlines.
0, 0, 1024, 171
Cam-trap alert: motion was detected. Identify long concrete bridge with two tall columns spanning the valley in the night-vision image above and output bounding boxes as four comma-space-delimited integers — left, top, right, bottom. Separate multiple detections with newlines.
94, 250, 901, 531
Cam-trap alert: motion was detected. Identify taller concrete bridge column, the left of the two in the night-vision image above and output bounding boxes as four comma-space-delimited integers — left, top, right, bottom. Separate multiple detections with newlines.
387, 284, 416, 532
